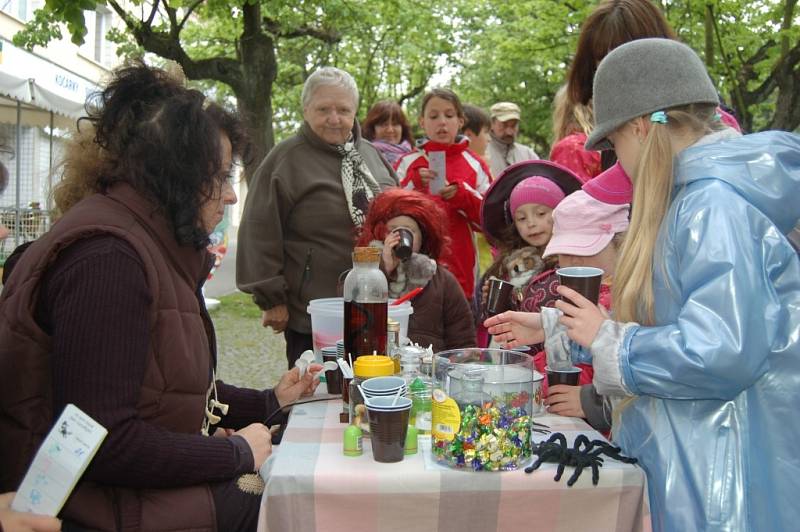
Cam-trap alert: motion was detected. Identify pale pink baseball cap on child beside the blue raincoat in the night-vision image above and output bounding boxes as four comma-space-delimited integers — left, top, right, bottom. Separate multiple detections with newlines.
542, 190, 630, 257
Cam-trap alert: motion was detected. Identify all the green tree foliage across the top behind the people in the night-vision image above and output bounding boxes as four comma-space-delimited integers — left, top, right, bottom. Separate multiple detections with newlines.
15, 0, 800, 163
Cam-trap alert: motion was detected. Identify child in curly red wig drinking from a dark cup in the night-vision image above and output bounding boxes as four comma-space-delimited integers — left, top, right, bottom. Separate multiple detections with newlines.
356, 188, 475, 351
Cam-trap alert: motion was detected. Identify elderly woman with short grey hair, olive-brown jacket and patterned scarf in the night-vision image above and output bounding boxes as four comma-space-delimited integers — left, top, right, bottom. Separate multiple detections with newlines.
236, 67, 397, 368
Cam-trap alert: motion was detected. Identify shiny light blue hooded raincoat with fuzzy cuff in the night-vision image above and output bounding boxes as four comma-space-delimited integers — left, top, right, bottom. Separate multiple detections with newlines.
614, 132, 800, 532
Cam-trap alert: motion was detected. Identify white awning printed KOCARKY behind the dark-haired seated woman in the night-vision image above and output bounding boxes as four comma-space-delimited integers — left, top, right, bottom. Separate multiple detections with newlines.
0, 39, 99, 118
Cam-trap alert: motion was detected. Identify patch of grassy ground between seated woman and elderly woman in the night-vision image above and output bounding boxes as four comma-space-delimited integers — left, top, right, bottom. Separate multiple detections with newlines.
205, 241, 286, 389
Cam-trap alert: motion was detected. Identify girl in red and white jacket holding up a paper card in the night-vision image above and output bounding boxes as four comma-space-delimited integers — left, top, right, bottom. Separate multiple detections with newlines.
395, 89, 491, 299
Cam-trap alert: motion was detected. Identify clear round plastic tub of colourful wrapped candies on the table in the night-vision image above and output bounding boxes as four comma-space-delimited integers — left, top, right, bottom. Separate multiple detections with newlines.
431, 348, 539, 471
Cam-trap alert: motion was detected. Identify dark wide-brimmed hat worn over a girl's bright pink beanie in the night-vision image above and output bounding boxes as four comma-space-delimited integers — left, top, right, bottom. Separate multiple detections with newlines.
481, 160, 581, 245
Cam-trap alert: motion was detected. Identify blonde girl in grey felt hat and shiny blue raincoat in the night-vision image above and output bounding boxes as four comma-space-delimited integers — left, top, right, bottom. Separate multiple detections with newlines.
486, 39, 800, 532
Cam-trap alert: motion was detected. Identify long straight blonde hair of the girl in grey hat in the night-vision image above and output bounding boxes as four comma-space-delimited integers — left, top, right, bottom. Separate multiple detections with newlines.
612, 104, 724, 325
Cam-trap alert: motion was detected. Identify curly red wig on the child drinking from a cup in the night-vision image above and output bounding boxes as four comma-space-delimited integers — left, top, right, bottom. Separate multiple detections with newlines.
356, 187, 450, 260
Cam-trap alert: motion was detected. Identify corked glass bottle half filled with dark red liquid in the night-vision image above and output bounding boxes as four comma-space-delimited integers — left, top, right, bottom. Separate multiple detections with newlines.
344, 247, 389, 362
